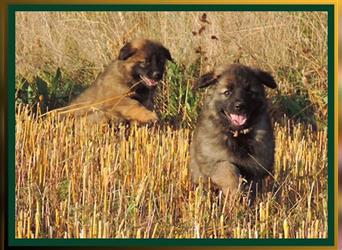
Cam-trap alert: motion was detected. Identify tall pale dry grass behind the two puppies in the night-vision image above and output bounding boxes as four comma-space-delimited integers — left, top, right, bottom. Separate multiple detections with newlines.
16, 12, 327, 85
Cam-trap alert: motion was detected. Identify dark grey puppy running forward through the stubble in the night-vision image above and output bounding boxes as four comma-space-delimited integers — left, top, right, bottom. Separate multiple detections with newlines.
190, 64, 277, 194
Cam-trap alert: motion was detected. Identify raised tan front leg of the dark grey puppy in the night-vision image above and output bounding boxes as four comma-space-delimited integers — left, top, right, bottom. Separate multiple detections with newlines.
210, 162, 240, 195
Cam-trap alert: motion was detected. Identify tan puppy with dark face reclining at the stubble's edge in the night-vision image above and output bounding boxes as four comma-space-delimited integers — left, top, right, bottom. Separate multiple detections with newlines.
69, 39, 172, 123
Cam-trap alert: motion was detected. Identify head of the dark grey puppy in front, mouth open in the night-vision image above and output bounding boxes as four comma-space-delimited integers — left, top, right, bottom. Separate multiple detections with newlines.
195, 64, 276, 130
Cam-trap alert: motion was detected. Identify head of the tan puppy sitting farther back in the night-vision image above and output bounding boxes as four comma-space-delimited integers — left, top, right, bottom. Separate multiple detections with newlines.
118, 39, 172, 88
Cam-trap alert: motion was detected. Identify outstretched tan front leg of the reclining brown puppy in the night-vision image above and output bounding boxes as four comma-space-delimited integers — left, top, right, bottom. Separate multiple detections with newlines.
115, 98, 158, 123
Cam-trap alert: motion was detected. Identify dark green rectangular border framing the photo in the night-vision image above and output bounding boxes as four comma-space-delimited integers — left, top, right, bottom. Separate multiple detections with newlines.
7, 4, 337, 247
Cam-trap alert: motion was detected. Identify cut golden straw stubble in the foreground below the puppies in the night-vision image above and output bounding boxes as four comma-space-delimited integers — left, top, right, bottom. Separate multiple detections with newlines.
16, 103, 328, 238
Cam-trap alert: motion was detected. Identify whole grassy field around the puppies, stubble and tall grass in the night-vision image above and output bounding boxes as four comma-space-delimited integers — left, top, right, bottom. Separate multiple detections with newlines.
15, 12, 328, 238
